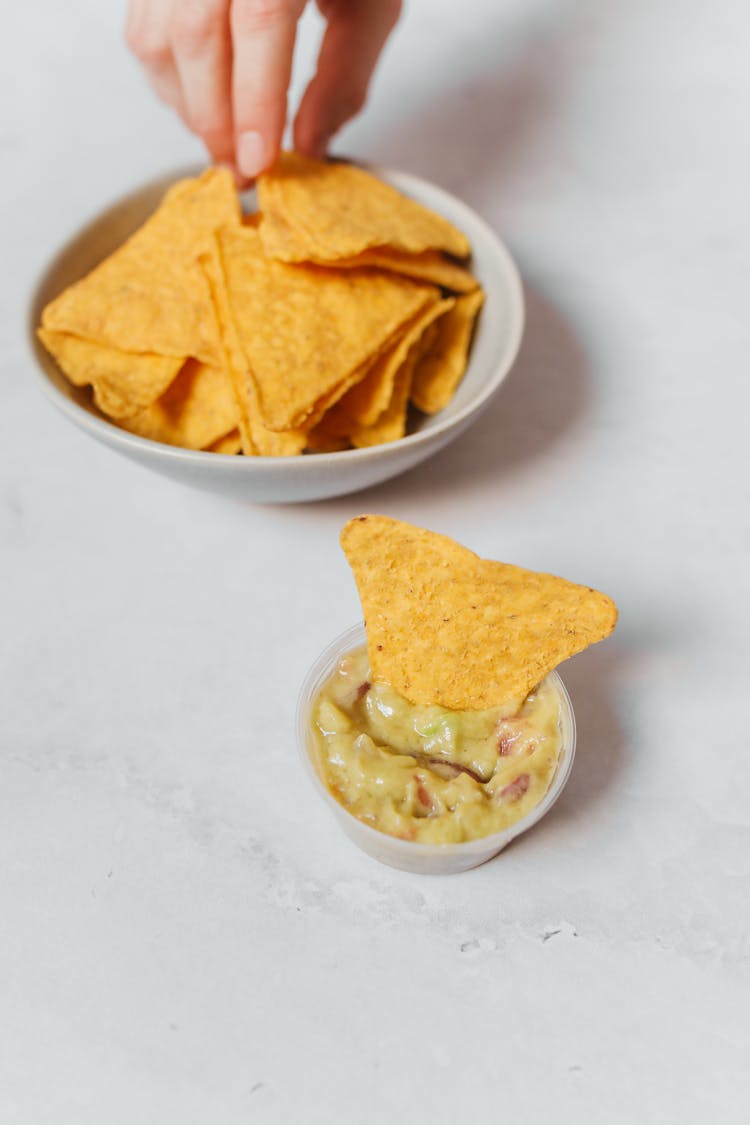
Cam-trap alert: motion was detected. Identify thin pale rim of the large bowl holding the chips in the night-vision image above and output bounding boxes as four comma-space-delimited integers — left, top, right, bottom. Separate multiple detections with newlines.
27, 161, 525, 475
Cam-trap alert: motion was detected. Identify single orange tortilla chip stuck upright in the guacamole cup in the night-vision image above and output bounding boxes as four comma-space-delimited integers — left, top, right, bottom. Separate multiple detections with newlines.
341, 515, 617, 711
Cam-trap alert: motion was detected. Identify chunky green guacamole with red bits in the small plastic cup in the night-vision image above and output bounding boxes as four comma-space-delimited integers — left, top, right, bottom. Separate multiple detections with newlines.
313, 647, 562, 844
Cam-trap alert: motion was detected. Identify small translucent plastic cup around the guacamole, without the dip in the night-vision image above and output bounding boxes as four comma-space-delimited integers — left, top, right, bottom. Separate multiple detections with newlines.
297, 624, 576, 875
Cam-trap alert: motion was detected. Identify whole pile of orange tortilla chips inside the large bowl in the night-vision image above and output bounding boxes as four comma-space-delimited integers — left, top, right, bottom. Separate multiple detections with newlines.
39, 153, 484, 456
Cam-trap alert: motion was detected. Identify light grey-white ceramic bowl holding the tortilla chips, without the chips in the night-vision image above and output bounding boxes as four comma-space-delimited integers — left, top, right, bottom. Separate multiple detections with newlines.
29, 168, 524, 503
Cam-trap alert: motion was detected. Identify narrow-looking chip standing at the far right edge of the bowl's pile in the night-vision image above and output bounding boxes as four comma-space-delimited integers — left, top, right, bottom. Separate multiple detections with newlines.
412, 289, 485, 414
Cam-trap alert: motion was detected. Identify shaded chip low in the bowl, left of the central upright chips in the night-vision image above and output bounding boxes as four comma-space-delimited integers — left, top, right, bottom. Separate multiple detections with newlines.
120, 360, 237, 449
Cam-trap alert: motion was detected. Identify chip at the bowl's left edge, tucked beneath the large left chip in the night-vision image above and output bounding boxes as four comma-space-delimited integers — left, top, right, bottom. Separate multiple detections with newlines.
37, 329, 183, 419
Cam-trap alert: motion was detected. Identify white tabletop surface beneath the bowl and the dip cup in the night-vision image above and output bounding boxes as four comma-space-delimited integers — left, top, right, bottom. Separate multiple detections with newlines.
0, 0, 750, 1125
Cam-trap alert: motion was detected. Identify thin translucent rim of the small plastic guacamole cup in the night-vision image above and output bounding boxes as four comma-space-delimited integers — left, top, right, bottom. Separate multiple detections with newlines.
295, 622, 576, 860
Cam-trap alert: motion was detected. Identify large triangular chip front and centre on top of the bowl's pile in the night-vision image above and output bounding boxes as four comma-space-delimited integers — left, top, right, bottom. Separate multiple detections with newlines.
213, 227, 437, 431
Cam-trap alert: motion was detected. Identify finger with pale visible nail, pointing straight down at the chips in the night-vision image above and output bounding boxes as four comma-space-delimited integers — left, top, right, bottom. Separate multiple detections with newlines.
231, 0, 305, 179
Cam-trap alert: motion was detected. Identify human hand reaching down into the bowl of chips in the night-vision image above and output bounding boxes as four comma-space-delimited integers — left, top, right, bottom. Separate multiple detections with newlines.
125, 0, 401, 179
